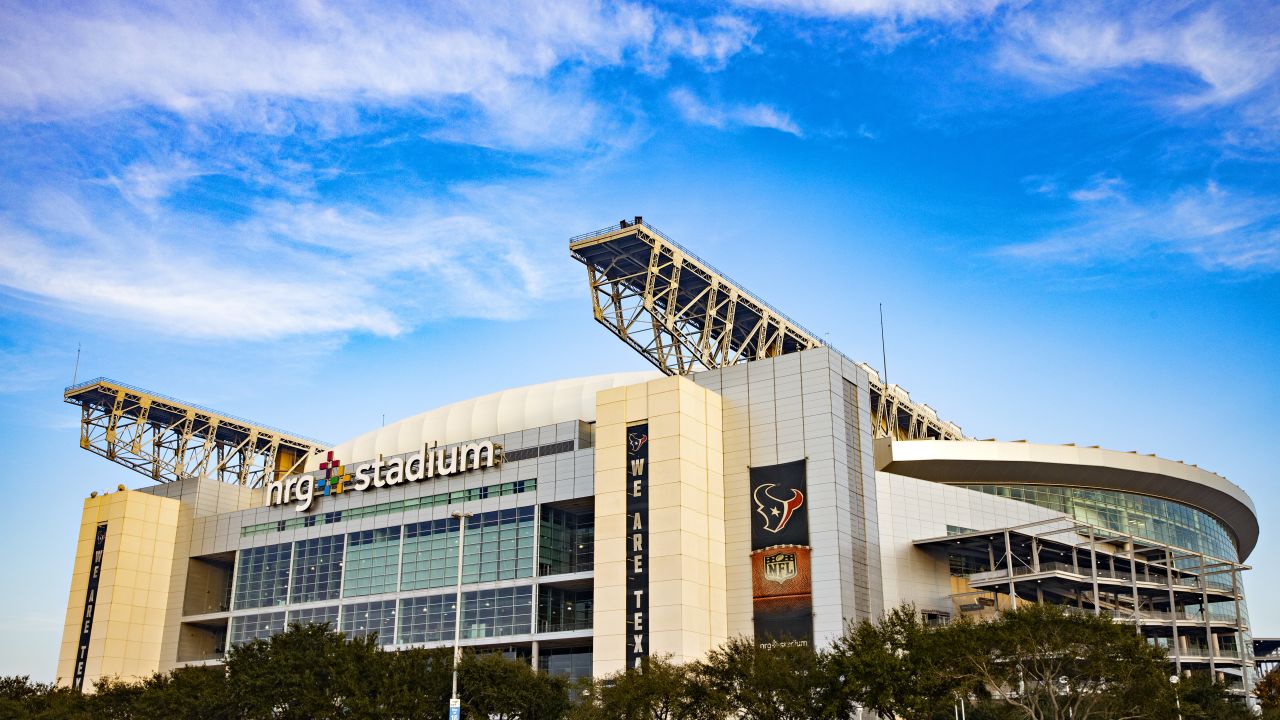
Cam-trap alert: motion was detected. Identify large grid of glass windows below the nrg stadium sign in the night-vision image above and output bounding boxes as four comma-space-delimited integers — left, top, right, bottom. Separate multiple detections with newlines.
232, 506, 573, 644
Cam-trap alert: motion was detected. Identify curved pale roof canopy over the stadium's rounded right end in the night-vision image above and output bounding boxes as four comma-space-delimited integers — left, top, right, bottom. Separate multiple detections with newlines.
876, 438, 1258, 562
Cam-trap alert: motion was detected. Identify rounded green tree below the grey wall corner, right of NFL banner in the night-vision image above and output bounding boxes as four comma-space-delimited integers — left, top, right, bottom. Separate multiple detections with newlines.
829, 605, 974, 720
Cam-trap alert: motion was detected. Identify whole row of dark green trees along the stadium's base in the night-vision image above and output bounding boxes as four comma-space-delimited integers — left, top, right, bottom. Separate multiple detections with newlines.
0, 605, 1254, 720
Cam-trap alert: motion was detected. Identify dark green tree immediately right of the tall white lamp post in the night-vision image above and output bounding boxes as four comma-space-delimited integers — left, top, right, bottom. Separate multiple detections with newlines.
458, 653, 570, 720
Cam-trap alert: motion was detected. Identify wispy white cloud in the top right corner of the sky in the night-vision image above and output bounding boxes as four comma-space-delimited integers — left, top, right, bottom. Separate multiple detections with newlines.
997, 4, 1280, 109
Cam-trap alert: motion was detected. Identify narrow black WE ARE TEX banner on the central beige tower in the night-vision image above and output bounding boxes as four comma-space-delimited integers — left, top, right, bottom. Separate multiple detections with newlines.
626, 423, 649, 670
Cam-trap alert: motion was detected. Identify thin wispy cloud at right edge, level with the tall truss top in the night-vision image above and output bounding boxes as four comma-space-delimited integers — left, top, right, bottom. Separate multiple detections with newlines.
997, 182, 1280, 273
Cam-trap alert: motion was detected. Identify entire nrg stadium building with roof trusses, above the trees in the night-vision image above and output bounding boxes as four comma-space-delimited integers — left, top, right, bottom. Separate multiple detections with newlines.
58, 218, 1258, 692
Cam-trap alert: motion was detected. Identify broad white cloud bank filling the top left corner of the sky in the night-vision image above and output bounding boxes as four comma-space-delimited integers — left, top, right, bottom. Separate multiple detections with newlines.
0, 0, 754, 149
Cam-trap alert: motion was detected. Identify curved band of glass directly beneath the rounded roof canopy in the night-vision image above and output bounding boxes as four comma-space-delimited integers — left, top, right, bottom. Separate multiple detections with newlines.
961, 484, 1239, 562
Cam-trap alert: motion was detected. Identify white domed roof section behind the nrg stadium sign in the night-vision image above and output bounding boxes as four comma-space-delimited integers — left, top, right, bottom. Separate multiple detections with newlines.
317, 370, 662, 470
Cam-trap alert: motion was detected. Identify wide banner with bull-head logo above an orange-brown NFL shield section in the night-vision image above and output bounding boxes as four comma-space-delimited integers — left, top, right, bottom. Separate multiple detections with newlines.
751, 460, 813, 644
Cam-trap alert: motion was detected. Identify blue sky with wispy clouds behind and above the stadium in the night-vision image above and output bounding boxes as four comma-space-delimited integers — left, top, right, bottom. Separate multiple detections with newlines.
0, 0, 1280, 679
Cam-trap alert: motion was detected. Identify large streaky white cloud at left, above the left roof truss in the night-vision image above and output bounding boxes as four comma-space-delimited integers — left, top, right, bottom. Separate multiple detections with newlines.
0, 178, 588, 341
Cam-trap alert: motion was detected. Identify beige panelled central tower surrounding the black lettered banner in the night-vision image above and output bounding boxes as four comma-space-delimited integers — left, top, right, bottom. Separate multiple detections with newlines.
593, 377, 728, 676
